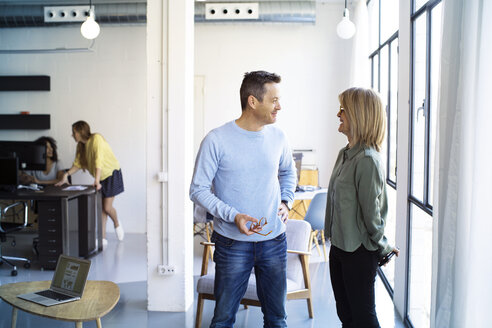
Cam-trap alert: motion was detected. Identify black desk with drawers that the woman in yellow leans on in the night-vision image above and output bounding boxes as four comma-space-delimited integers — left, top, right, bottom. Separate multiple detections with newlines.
0, 186, 102, 269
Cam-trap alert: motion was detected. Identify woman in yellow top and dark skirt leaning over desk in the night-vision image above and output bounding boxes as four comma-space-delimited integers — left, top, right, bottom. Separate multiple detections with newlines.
57, 121, 125, 246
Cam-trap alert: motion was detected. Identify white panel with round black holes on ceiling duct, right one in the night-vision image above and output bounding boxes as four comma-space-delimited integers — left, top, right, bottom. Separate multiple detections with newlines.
205, 2, 259, 20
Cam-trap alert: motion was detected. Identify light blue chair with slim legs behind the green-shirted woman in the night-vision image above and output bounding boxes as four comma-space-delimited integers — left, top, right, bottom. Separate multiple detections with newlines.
304, 192, 328, 262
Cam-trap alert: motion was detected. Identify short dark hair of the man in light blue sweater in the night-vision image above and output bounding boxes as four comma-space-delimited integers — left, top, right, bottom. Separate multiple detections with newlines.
239, 71, 281, 110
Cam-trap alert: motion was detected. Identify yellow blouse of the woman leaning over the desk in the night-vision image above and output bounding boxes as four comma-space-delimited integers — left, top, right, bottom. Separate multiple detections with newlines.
73, 133, 120, 181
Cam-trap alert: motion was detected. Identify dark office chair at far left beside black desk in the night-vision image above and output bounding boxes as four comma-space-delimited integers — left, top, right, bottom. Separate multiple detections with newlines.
0, 201, 31, 276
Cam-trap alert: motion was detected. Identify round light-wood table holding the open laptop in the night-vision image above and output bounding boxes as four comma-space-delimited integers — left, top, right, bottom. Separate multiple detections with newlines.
0, 280, 120, 328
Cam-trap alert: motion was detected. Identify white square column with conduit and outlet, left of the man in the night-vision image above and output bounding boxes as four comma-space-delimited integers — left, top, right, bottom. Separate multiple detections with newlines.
146, 0, 194, 311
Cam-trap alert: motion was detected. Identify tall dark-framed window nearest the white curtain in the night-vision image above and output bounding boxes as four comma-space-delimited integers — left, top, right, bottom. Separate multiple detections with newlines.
407, 0, 442, 328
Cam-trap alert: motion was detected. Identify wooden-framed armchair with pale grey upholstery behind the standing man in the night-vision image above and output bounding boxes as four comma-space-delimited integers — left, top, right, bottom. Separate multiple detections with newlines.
195, 220, 314, 328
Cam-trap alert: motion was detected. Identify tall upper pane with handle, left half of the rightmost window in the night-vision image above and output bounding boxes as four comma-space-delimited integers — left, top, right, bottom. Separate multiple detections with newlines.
411, 13, 427, 201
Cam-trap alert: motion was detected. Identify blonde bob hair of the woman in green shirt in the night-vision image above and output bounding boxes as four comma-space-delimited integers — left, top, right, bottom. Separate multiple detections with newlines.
338, 88, 386, 151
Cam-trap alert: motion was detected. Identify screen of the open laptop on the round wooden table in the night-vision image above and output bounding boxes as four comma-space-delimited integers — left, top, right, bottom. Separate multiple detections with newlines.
51, 255, 91, 295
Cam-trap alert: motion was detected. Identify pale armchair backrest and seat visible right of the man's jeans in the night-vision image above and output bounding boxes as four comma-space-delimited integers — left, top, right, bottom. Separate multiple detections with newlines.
285, 220, 311, 284
